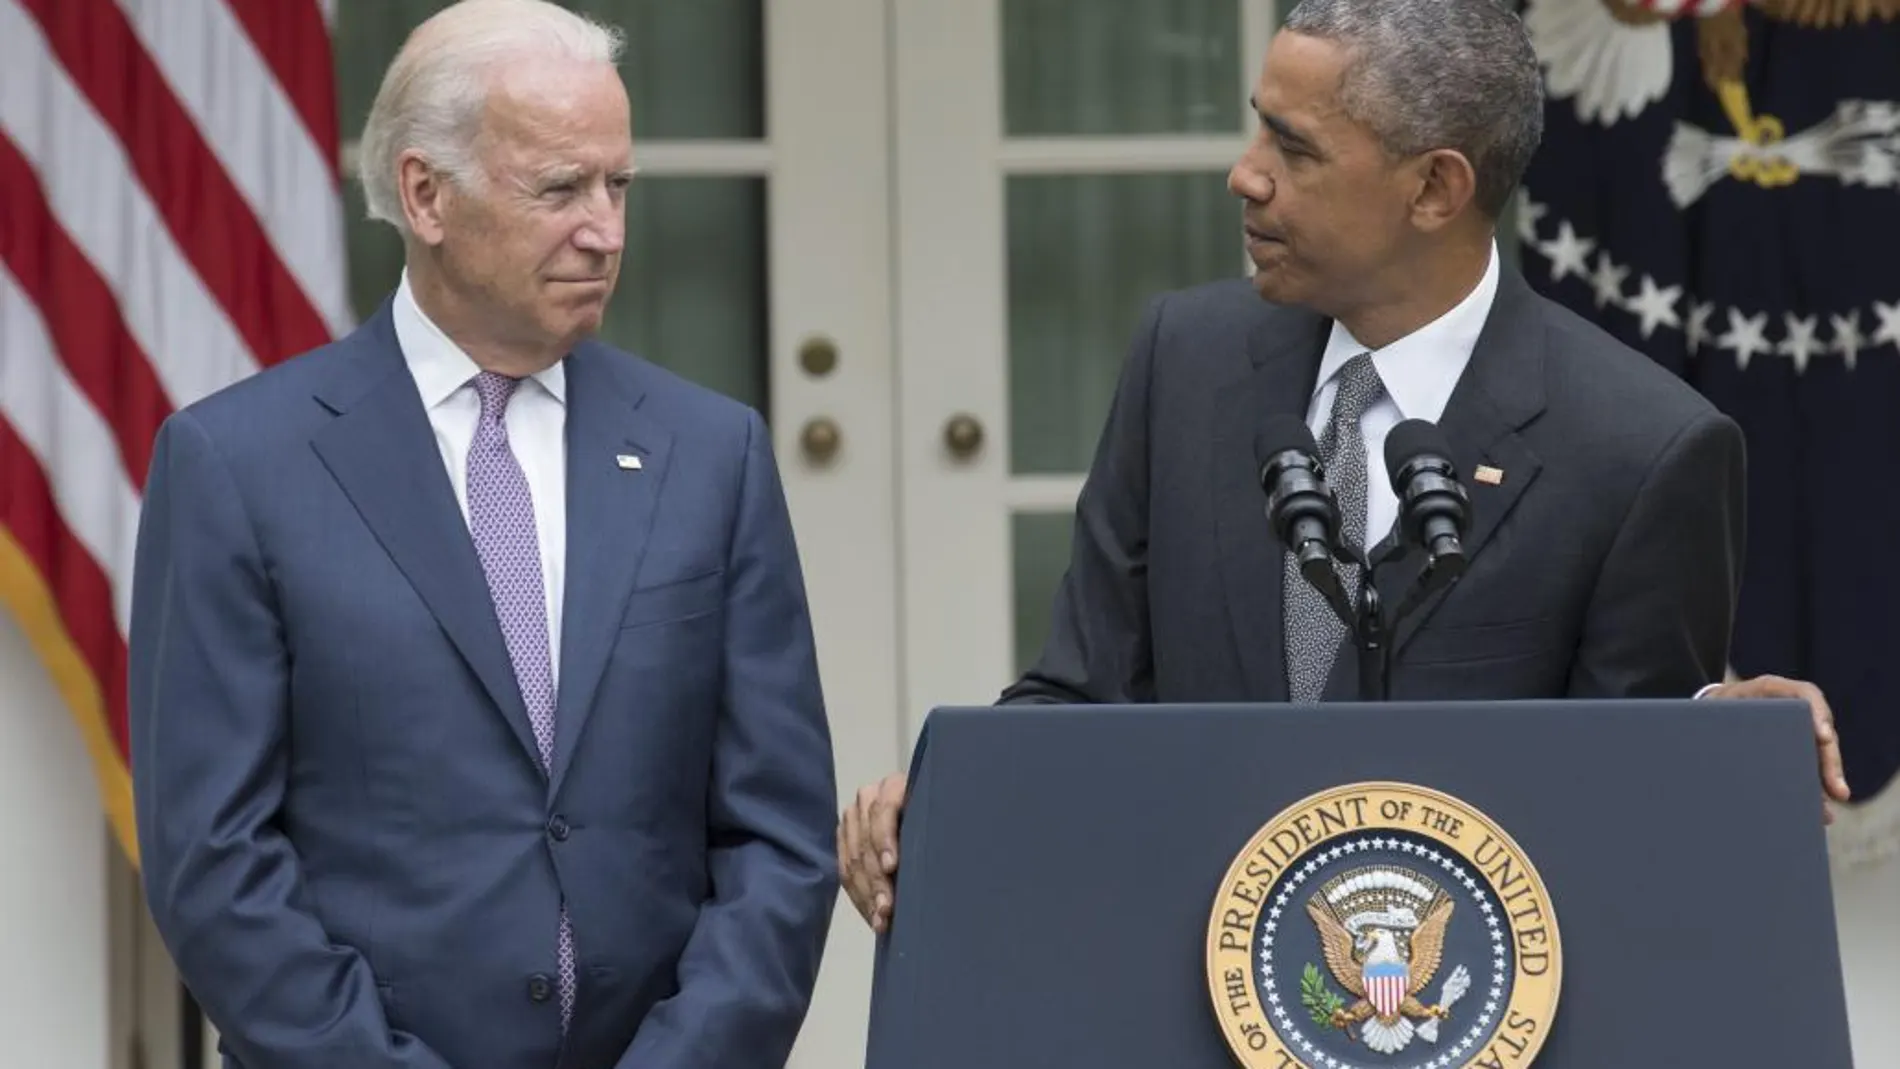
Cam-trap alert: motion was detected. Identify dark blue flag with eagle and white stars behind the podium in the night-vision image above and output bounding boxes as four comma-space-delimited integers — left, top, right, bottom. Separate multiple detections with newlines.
1516, 0, 1900, 820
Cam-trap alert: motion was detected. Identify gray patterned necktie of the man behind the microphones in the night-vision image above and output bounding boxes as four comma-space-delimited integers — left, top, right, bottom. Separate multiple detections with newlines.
1281, 353, 1385, 703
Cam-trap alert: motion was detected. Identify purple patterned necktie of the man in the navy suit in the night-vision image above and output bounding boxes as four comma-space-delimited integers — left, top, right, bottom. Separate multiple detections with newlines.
469, 372, 574, 1035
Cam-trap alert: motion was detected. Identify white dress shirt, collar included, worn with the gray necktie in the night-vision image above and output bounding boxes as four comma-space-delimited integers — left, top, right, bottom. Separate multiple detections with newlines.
1307, 243, 1497, 551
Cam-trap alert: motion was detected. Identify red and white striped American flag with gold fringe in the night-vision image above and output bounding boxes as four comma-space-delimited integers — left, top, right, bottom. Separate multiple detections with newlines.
0, 0, 352, 860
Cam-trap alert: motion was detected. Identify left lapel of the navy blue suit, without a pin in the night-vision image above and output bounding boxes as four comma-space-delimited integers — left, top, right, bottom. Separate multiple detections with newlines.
312, 304, 542, 767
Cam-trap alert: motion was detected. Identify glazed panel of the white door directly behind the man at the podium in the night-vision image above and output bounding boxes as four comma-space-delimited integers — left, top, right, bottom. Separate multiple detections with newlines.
1001, 0, 1271, 672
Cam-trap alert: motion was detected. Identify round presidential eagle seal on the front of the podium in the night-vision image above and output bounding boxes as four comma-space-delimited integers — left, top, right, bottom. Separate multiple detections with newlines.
1207, 782, 1564, 1069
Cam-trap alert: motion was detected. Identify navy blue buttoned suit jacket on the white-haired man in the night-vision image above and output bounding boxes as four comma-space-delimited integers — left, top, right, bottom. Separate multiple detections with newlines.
129, 304, 838, 1069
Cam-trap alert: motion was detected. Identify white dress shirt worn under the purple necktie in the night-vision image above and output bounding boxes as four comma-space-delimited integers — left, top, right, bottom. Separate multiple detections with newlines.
391, 270, 568, 684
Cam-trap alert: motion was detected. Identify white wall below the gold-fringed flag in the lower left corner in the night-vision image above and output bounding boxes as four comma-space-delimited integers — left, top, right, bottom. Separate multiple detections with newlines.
0, 610, 116, 1069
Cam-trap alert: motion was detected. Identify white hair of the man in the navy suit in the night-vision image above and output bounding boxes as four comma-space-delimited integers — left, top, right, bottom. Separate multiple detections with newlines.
357, 0, 625, 234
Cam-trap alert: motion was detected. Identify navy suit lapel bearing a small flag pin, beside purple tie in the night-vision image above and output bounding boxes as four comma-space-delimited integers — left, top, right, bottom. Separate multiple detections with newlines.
551, 344, 673, 792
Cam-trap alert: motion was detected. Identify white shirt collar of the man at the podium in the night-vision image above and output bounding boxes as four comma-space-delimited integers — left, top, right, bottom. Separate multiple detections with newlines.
1315, 241, 1497, 423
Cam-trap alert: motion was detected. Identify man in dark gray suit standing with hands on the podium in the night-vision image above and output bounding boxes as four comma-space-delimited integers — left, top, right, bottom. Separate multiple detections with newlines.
838, 0, 1847, 930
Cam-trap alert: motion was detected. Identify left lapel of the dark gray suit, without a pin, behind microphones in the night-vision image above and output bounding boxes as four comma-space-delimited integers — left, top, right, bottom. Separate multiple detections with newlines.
1210, 313, 1328, 701
